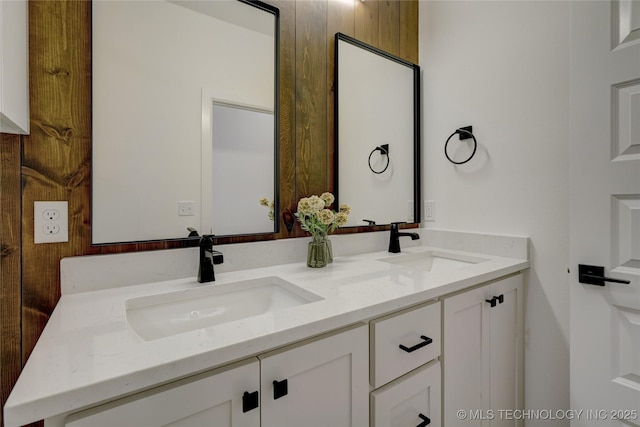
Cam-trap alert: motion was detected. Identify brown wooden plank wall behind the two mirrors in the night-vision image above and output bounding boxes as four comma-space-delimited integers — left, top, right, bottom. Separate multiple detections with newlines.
0, 0, 418, 426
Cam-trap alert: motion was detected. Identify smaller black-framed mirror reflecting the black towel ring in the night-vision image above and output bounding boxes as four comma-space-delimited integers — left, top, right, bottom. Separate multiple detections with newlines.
335, 33, 420, 226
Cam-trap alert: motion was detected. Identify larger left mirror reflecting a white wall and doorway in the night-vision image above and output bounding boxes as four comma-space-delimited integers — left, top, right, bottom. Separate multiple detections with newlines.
91, 0, 278, 244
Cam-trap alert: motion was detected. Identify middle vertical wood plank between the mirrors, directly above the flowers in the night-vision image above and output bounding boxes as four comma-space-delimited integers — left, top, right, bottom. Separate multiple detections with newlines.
295, 1, 327, 198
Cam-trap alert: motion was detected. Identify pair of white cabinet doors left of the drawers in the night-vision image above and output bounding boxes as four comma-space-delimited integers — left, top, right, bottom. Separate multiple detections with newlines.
62, 324, 369, 427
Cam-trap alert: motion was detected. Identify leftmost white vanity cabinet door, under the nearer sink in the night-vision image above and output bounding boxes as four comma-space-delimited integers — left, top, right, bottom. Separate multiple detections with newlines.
65, 359, 260, 427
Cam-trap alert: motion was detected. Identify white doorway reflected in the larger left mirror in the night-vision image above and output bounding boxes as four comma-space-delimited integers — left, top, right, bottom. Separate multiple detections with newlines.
202, 100, 276, 236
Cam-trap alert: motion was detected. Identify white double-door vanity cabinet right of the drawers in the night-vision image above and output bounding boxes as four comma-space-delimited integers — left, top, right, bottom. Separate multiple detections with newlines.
443, 274, 524, 427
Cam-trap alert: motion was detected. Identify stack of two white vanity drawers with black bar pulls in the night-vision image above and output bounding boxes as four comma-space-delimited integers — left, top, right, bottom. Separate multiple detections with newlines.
370, 302, 442, 427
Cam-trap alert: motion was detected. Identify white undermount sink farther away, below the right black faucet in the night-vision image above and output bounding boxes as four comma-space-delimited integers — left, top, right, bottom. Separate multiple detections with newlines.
378, 251, 487, 273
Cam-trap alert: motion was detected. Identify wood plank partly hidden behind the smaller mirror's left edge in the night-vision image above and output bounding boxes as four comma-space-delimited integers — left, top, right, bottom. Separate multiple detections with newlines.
327, 0, 359, 194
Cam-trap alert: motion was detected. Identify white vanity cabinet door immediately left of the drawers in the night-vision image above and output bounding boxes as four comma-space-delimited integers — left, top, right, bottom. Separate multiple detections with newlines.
260, 325, 369, 427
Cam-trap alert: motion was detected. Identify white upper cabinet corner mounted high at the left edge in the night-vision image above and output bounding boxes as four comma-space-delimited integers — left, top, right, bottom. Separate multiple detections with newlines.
0, 0, 29, 134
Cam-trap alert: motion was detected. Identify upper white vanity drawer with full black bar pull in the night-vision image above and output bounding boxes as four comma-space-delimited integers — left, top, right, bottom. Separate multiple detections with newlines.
369, 302, 440, 388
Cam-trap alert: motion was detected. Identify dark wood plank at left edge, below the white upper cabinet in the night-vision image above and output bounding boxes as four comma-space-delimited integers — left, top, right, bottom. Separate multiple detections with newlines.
0, 134, 22, 424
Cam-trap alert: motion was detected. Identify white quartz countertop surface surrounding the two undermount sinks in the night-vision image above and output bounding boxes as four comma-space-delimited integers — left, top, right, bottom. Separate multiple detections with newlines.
4, 242, 529, 427
